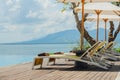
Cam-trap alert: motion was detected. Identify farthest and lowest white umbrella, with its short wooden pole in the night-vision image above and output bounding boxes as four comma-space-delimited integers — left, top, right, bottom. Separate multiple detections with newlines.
87, 15, 120, 41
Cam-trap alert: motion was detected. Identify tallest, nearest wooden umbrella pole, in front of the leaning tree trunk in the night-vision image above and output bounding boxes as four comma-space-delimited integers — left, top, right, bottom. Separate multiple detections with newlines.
80, 0, 85, 50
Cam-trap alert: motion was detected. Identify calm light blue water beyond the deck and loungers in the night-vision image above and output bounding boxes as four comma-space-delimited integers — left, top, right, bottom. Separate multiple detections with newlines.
0, 44, 76, 67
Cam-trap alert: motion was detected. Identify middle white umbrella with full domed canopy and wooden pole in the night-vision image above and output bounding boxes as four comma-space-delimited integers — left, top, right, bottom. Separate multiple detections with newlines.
75, 2, 120, 41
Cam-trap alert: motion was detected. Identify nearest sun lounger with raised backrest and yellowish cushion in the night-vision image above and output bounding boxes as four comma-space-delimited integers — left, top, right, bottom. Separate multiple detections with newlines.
32, 42, 108, 69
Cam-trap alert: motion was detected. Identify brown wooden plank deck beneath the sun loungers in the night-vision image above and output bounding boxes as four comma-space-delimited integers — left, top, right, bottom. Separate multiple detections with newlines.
0, 59, 120, 80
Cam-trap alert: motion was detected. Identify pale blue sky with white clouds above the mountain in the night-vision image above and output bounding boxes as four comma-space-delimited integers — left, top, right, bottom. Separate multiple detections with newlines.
0, 0, 119, 43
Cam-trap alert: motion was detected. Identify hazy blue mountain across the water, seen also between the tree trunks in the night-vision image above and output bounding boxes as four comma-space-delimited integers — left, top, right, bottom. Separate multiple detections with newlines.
2, 29, 120, 44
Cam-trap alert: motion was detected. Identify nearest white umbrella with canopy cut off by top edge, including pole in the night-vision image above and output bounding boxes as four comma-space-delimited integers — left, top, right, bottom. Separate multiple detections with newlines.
58, 0, 120, 50
